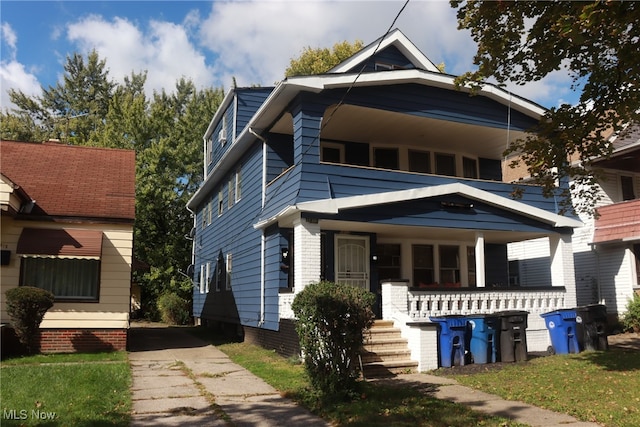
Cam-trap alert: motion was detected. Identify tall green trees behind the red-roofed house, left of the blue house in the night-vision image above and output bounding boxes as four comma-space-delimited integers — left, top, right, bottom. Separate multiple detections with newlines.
1, 51, 224, 318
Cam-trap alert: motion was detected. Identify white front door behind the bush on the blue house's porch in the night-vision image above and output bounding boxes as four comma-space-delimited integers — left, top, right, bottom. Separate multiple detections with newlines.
335, 235, 369, 290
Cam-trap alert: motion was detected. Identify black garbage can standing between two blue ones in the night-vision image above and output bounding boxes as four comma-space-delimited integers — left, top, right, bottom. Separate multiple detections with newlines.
494, 310, 529, 362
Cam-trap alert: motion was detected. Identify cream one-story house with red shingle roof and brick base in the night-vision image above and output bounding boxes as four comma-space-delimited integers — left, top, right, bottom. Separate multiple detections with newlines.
0, 141, 135, 352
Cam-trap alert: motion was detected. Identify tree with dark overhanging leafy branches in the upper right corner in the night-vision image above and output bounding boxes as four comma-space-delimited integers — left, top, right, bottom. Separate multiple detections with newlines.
451, 0, 640, 212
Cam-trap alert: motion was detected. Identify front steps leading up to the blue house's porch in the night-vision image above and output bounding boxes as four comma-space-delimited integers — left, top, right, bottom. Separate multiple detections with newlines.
362, 320, 418, 378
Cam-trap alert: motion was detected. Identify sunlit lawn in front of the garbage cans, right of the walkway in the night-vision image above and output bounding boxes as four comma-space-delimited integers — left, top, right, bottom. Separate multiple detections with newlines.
440, 349, 640, 427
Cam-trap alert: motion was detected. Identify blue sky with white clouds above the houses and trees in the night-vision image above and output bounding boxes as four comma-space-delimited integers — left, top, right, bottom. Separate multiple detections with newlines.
0, 0, 577, 110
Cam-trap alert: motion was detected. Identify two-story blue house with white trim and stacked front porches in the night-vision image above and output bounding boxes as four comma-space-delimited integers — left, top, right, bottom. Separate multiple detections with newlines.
188, 30, 581, 369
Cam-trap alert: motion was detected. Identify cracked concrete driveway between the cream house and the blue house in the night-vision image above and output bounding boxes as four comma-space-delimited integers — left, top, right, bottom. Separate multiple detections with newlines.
129, 325, 328, 427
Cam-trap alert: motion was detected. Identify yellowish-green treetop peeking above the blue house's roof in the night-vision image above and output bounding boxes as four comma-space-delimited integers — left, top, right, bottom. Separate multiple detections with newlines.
285, 40, 363, 77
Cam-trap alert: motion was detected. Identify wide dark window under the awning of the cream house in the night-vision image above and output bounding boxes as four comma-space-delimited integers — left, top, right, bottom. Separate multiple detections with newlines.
20, 257, 100, 301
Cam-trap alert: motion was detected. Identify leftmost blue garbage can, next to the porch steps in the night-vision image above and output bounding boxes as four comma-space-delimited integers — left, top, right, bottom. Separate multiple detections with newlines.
430, 315, 468, 368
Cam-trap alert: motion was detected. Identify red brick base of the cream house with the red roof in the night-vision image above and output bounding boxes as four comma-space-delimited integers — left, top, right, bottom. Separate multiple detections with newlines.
40, 329, 127, 353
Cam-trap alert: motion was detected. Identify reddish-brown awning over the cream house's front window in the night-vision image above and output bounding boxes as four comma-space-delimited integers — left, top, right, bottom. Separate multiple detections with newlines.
16, 228, 102, 259
